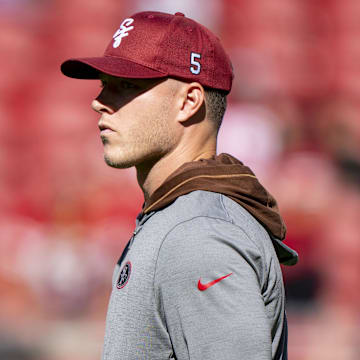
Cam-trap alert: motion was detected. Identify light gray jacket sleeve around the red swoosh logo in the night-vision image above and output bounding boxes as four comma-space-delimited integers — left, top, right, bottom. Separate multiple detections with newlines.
154, 216, 271, 360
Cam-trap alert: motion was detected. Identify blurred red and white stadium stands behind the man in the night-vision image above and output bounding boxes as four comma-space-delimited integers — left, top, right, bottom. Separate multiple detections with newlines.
0, 0, 360, 360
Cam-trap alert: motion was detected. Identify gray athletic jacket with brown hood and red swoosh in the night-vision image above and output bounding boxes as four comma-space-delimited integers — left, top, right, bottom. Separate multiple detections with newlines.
102, 154, 297, 360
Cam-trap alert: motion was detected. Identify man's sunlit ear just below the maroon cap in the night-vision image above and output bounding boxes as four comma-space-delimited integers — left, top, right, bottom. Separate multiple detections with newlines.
178, 82, 205, 122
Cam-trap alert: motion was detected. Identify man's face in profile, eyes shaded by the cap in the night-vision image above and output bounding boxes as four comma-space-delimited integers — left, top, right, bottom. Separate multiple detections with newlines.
92, 74, 179, 168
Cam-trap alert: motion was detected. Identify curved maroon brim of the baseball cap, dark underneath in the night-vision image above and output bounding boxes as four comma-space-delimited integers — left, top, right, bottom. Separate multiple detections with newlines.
61, 56, 168, 79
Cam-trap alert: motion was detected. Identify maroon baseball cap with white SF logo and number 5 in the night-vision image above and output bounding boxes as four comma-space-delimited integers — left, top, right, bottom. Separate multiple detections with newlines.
61, 11, 234, 92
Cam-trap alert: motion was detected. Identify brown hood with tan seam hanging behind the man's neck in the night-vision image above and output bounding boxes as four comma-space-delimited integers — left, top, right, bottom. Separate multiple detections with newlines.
143, 153, 298, 265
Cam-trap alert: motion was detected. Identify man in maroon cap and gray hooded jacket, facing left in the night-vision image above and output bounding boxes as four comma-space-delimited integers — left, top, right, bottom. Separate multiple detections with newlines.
61, 12, 297, 360
